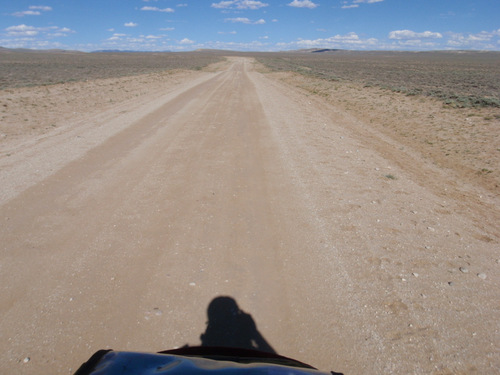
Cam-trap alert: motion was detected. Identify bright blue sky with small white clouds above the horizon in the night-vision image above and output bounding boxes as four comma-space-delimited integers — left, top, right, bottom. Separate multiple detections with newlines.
0, 0, 500, 51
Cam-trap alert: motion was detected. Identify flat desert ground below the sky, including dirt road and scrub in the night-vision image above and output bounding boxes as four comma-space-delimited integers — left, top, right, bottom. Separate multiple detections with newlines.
0, 50, 500, 374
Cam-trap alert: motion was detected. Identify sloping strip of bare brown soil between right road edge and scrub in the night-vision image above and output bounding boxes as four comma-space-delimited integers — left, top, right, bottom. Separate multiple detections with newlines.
274, 73, 500, 198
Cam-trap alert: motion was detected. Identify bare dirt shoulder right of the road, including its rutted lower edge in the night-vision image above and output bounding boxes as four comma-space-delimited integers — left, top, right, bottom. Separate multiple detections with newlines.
262, 69, 500, 241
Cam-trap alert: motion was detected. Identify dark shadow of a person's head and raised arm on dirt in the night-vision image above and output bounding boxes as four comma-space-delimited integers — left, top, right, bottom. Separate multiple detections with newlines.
200, 296, 276, 354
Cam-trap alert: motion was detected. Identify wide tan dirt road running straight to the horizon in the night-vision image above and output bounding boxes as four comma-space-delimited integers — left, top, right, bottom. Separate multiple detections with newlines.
0, 58, 500, 374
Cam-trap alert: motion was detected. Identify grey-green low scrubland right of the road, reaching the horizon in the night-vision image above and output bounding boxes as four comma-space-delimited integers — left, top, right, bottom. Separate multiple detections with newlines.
258, 51, 500, 108
